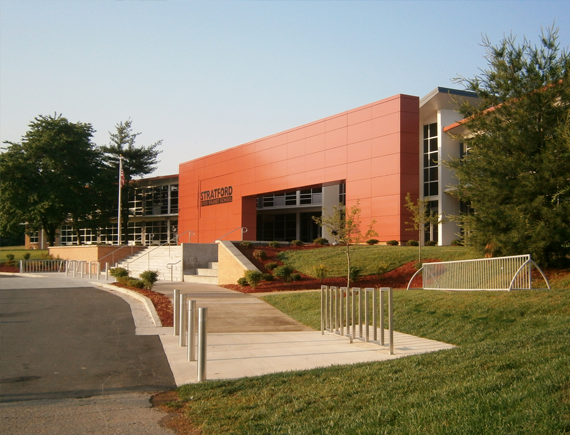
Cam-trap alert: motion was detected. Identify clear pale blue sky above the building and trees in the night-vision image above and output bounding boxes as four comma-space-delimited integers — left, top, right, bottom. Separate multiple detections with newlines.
0, 0, 570, 175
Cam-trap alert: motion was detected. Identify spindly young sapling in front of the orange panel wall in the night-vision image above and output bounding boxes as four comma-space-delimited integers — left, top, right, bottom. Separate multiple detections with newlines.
313, 202, 378, 287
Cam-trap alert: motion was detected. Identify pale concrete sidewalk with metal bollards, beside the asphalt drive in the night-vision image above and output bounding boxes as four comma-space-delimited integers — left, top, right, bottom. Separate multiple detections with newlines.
5, 274, 454, 386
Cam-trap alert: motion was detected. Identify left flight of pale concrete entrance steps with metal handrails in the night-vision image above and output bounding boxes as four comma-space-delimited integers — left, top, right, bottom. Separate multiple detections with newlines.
117, 246, 182, 282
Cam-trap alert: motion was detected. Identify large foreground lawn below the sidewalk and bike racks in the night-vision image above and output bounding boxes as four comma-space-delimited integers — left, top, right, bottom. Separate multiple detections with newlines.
173, 289, 570, 434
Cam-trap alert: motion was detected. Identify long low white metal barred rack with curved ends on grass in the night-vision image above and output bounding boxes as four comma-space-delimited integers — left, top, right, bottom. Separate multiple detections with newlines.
408, 255, 550, 291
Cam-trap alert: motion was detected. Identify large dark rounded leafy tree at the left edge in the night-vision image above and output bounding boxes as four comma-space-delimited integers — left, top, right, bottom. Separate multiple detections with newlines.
0, 114, 101, 245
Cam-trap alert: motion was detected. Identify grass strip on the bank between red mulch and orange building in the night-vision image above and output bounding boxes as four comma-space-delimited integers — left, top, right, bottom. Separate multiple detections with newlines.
279, 245, 481, 277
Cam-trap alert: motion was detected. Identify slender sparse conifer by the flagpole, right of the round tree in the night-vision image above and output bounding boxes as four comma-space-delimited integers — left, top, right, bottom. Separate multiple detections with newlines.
101, 119, 162, 245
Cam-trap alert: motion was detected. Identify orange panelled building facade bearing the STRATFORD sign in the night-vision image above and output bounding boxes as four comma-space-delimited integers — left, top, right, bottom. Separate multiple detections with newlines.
179, 95, 420, 243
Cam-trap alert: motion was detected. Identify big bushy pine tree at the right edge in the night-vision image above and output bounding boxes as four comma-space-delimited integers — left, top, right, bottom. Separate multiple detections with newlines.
445, 29, 570, 265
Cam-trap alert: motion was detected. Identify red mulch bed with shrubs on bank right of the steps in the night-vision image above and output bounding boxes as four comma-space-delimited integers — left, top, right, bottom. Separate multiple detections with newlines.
217, 245, 439, 293
